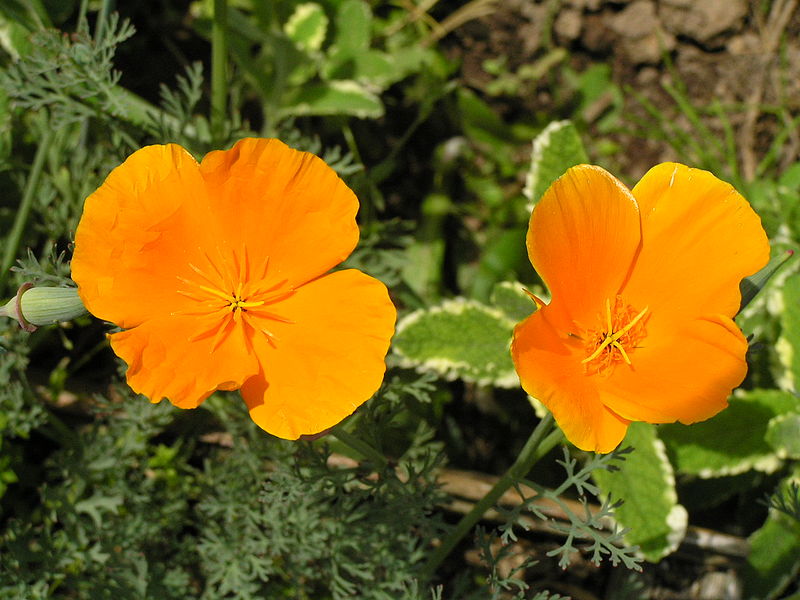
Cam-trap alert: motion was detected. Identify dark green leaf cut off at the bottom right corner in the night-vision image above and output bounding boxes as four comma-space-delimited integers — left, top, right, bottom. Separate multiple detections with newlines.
743, 492, 800, 600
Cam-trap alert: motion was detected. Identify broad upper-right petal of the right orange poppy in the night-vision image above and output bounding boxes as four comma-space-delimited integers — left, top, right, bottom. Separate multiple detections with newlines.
624, 163, 769, 317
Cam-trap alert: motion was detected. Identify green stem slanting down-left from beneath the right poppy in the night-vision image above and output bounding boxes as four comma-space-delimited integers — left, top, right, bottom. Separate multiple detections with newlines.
419, 413, 563, 582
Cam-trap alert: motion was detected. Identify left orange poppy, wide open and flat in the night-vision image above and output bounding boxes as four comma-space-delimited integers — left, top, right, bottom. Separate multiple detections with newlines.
72, 139, 396, 439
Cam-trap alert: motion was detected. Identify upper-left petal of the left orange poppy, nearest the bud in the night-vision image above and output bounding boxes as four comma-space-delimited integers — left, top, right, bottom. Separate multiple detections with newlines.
72, 144, 211, 328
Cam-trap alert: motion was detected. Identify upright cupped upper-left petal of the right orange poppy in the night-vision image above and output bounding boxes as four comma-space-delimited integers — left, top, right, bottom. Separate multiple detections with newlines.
527, 165, 641, 326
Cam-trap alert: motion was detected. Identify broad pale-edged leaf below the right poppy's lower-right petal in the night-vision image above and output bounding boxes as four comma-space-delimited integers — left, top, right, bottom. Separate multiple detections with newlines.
659, 390, 800, 477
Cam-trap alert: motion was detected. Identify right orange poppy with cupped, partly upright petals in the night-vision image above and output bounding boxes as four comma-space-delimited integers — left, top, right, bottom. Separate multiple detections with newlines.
511, 163, 769, 452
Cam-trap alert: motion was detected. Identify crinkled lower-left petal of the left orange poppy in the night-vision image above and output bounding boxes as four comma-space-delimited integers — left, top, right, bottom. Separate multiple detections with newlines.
109, 316, 258, 408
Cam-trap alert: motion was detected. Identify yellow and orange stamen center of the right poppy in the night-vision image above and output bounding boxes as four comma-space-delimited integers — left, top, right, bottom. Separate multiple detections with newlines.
581, 296, 647, 375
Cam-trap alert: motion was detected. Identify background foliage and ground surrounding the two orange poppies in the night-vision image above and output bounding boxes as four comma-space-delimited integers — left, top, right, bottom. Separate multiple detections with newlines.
0, 0, 800, 600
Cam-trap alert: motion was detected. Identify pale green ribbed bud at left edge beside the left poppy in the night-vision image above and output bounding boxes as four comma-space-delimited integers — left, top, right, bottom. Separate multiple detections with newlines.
0, 283, 88, 331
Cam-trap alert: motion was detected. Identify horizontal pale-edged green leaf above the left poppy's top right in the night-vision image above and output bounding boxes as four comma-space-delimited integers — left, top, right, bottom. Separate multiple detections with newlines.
281, 81, 383, 119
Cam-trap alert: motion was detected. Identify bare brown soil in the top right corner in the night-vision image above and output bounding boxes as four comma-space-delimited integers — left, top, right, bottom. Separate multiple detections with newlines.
445, 0, 800, 181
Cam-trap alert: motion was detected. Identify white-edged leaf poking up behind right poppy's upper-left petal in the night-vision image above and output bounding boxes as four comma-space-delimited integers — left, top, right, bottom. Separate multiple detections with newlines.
524, 121, 589, 205
